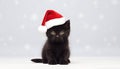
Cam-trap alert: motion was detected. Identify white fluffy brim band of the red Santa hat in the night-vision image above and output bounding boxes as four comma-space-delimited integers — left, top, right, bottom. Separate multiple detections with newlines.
46, 17, 65, 29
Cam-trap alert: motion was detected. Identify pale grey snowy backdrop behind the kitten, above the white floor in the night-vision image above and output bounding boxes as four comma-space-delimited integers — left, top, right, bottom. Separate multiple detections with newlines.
0, 0, 120, 57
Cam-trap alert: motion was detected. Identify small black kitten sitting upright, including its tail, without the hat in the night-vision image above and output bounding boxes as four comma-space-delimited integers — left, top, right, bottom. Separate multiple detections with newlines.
31, 20, 70, 64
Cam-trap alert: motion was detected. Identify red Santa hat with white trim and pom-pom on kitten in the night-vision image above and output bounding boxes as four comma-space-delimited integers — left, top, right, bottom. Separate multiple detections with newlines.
38, 10, 65, 32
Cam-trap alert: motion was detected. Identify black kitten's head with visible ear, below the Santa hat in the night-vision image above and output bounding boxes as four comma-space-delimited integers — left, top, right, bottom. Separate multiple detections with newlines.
46, 20, 70, 43
